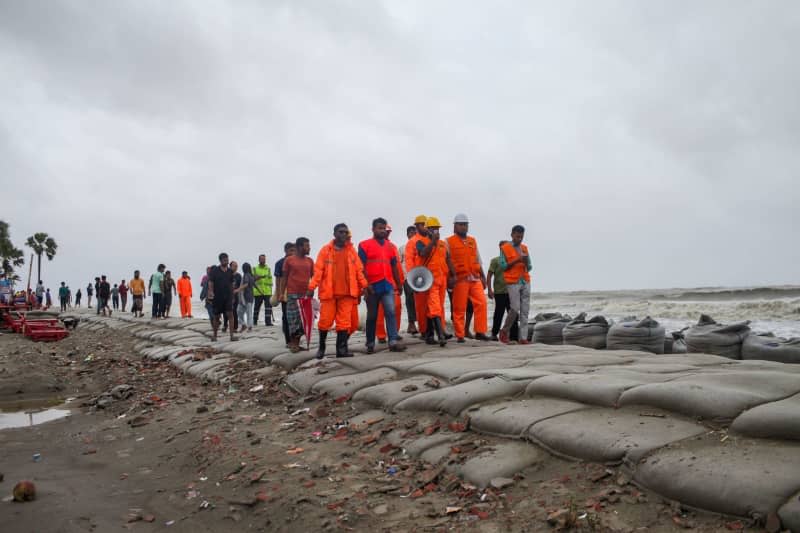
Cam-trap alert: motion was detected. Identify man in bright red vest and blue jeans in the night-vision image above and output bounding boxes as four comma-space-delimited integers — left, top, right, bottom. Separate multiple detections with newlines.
358, 217, 406, 353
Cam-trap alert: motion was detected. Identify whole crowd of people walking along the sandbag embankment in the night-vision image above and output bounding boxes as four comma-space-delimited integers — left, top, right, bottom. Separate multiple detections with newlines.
9, 214, 532, 358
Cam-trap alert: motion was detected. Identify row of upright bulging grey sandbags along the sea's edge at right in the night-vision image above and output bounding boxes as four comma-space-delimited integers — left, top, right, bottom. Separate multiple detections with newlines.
532, 313, 800, 363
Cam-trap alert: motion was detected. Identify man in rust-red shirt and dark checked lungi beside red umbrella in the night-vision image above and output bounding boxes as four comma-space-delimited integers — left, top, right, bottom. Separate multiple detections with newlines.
278, 237, 314, 353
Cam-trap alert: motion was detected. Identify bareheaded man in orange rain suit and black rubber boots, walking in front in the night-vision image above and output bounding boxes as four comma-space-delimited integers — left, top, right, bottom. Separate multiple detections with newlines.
308, 224, 367, 359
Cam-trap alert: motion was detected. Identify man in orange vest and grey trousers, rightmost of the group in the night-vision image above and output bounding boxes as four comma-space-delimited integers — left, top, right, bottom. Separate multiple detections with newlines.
499, 225, 533, 344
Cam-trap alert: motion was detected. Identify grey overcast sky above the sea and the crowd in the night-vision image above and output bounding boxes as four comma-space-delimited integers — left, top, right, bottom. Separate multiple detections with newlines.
0, 0, 800, 290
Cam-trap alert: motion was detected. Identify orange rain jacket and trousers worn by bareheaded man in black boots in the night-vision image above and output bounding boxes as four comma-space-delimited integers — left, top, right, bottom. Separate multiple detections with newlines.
308, 241, 367, 334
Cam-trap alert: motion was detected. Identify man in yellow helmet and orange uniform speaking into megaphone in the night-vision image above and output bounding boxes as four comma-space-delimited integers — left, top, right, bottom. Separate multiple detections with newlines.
415, 217, 455, 346
